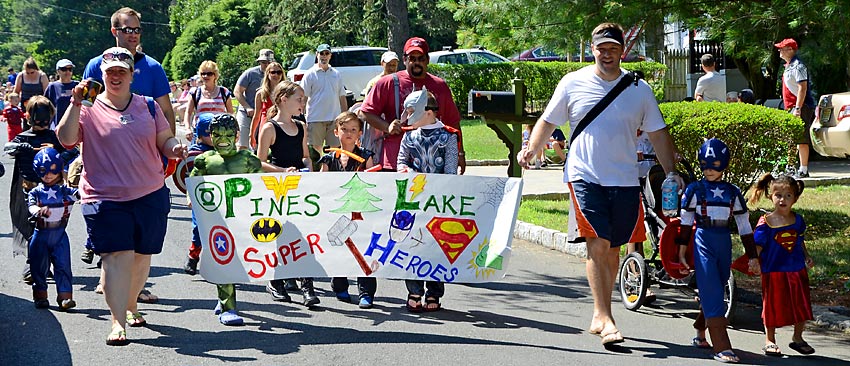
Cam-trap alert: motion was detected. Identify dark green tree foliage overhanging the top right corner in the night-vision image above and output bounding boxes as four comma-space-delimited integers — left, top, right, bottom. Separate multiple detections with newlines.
672, 0, 850, 97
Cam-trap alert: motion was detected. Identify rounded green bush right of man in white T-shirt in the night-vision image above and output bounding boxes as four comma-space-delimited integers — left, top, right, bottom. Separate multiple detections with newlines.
660, 102, 804, 190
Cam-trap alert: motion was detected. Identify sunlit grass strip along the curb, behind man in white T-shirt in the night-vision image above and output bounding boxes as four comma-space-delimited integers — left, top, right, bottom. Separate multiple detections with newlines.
517, 186, 850, 305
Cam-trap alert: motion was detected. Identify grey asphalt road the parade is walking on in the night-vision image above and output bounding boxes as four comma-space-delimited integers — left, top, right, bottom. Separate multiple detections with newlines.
0, 153, 850, 366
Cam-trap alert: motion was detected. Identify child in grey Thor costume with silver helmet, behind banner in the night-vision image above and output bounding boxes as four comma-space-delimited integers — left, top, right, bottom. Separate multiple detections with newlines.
397, 87, 459, 312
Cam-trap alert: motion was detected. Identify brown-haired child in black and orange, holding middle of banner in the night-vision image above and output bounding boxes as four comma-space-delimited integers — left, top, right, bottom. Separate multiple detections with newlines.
319, 111, 378, 309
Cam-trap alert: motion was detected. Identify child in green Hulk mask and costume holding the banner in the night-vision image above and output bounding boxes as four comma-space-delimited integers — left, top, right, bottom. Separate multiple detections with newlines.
189, 114, 262, 325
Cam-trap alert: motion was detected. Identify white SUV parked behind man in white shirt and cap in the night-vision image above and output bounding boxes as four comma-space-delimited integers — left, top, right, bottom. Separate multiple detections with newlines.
286, 46, 387, 103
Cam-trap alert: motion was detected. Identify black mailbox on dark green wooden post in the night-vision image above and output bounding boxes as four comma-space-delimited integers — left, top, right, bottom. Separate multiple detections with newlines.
468, 69, 538, 177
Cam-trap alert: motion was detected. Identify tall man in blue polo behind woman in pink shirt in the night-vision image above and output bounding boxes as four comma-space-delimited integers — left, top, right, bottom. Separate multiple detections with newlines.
83, 7, 175, 133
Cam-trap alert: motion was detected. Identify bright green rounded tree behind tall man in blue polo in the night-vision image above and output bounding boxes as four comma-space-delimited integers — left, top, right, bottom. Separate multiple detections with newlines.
169, 0, 261, 79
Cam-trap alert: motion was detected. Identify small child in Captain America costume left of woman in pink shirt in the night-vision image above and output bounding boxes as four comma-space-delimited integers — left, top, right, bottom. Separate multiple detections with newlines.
27, 147, 79, 311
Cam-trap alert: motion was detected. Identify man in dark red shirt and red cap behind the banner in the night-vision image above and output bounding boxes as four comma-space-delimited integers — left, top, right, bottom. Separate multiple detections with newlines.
360, 37, 466, 174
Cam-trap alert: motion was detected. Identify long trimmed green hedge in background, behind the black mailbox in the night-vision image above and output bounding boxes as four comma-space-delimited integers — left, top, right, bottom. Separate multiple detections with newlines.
428, 62, 667, 115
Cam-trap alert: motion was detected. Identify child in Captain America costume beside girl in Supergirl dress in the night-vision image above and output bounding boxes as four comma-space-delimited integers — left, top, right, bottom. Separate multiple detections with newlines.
676, 138, 759, 363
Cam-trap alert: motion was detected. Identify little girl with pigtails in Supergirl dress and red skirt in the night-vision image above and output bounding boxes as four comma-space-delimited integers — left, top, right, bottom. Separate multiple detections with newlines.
750, 174, 815, 356
